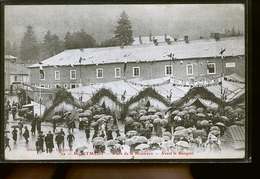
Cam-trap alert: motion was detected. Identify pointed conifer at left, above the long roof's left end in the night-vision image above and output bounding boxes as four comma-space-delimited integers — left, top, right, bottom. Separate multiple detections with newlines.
20, 25, 39, 63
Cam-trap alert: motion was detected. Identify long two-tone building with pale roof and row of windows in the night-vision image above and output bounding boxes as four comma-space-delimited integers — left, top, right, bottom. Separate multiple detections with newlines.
28, 36, 245, 89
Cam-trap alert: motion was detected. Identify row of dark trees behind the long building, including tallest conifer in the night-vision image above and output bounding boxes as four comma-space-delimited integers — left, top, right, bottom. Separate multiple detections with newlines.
5, 11, 134, 64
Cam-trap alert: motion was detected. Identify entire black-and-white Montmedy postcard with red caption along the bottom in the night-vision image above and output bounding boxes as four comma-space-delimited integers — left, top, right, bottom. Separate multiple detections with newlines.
1, 3, 249, 161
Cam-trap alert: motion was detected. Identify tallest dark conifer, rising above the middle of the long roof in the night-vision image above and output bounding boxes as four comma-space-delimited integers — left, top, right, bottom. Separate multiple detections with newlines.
115, 11, 134, 45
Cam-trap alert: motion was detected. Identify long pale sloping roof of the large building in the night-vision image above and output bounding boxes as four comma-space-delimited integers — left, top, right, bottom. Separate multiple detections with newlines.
29, 37, 245, 68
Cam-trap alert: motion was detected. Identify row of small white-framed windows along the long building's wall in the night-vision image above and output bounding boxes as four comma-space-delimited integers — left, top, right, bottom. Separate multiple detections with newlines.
42, 63, 216, 80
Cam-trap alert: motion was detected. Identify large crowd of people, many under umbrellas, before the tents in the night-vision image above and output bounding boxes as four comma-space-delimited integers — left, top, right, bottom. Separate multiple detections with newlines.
6, 100, 245, 155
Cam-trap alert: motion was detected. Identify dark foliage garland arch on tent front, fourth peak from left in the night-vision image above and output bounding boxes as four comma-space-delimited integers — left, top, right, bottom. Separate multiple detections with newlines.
171, 87, 225, 107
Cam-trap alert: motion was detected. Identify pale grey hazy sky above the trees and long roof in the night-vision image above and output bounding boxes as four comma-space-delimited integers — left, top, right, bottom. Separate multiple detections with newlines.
5, 4, 245, 44
